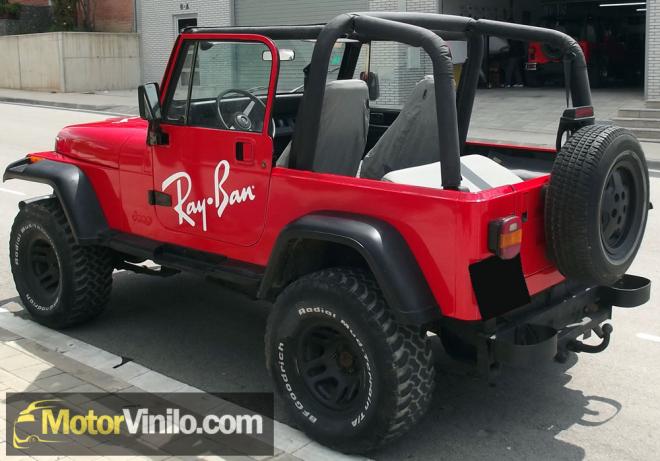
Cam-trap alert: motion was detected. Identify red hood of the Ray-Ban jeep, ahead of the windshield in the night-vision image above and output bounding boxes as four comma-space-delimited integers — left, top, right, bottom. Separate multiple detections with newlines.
55, 117, 148, 168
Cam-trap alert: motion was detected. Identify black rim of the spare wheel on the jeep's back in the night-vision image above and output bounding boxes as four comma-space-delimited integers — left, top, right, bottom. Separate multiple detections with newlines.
600, 158, 644, 263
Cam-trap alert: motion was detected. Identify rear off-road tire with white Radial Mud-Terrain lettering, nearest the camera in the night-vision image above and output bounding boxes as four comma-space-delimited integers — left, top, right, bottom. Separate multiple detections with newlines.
266, 268, 435, 453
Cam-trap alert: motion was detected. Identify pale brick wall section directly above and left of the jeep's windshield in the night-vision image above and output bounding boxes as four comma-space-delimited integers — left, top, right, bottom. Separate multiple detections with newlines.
137, 0, 232, 82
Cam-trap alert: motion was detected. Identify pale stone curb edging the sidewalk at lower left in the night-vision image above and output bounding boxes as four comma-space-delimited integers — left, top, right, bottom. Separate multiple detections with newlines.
0, 302, 368, 461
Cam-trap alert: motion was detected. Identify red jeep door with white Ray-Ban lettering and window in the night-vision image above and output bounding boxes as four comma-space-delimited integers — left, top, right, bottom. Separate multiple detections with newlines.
151, 34, 279, 245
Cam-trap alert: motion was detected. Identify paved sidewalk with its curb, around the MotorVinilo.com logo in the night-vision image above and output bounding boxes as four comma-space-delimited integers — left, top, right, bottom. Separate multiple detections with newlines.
0, 303, 364, 461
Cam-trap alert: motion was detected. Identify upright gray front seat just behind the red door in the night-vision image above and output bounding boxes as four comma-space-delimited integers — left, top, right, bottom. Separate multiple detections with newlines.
276, 80, 369, 176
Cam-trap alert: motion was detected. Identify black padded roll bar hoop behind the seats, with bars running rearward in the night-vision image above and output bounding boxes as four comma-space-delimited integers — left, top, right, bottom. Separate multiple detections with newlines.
290, 12, 591, 189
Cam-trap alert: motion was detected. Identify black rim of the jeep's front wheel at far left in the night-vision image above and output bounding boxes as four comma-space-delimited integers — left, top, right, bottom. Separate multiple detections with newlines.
25, 236, 60, 305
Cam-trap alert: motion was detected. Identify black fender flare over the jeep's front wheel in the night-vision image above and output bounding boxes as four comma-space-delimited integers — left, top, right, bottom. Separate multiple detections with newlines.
2, 158, 110, 245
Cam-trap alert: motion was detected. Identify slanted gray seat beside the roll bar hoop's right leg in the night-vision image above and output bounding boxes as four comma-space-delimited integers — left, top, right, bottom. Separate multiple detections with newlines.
360, 75, 440, 179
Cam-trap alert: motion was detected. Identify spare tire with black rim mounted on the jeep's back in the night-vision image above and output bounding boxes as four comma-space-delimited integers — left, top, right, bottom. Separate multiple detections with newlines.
545, 125, 649, 285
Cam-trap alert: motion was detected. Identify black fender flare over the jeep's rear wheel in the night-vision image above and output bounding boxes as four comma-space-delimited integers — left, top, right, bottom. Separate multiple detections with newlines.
257, 212, 441, 325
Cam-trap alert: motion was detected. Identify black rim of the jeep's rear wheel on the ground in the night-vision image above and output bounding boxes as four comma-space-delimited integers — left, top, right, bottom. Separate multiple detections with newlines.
297, 323, 366, 411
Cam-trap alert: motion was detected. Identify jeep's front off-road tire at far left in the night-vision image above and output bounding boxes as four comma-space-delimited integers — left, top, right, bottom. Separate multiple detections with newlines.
9, 198, 113, 329
